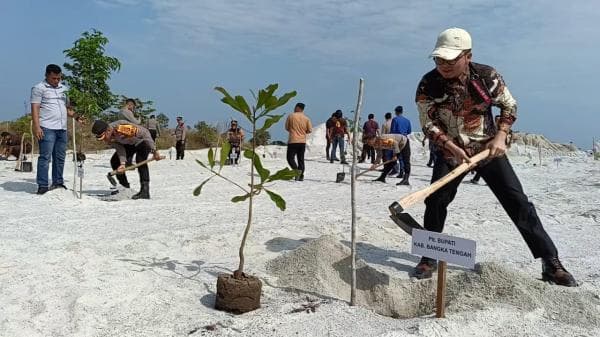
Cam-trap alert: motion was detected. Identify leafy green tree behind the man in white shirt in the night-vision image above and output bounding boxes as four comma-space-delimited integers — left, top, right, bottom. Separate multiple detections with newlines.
63, 29, 121, 118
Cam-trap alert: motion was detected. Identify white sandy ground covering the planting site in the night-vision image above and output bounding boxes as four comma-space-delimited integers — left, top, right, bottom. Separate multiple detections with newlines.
0, 124, 600, 337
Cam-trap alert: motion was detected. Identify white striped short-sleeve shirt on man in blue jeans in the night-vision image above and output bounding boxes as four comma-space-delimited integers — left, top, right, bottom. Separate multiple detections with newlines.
31, 80, 69, 130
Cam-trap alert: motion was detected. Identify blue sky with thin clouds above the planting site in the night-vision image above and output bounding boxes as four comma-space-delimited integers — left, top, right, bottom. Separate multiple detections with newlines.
0, 0, 600, 149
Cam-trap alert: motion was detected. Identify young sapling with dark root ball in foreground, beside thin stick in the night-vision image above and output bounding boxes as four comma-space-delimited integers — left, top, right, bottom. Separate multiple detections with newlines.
194, 84, 298, 313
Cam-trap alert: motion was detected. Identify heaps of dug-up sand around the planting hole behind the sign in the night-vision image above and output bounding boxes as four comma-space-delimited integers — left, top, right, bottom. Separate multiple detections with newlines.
267, 236, 600, 326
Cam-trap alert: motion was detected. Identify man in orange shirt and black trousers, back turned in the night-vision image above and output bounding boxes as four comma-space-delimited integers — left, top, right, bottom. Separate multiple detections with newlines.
285, 103, 312, 181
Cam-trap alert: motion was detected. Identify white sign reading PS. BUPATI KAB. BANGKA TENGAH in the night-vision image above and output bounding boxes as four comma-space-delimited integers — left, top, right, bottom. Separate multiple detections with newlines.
411, 229, 476, 268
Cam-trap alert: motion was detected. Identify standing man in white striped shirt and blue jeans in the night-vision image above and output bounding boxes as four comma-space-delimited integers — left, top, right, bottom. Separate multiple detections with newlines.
31, 64, 80, 194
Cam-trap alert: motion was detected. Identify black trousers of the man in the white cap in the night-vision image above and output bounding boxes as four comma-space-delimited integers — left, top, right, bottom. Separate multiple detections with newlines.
423, 156, 558, 258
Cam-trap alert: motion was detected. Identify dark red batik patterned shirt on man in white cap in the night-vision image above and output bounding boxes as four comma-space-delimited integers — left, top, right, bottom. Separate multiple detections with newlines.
415, 63, 517, 148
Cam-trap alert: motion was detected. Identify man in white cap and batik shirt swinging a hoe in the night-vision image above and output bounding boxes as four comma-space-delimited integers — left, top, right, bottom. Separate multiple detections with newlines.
414, 28, 577, 287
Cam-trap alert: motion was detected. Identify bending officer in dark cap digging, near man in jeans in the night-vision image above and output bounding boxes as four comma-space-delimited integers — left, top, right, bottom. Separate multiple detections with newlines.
92, 120, 161, 199
